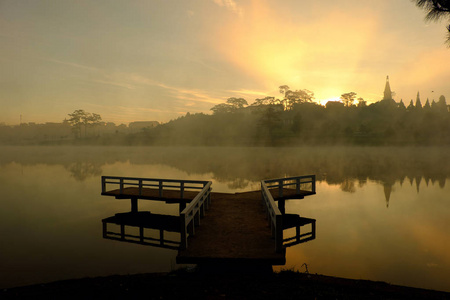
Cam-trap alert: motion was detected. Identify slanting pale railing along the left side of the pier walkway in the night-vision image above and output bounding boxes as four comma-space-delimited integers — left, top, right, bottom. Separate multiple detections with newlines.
180, 181, 212, 250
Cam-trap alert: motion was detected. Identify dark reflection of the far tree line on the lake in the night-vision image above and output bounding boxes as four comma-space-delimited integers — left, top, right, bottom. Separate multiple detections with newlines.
0, 146, 450, 193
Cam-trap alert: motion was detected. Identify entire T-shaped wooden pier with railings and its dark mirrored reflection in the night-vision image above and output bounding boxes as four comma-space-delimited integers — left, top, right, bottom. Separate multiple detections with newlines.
102, 175, 315, 265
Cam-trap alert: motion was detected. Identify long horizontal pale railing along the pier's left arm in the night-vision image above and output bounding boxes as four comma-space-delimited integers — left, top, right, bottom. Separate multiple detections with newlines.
102, 176, 209, 199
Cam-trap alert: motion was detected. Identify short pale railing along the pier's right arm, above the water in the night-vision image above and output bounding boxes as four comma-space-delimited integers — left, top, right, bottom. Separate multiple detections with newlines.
263, 175, 316, 198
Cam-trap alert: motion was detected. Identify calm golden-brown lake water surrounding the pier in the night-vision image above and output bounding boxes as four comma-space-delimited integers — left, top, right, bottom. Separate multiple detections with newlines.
0, 147, 450, 291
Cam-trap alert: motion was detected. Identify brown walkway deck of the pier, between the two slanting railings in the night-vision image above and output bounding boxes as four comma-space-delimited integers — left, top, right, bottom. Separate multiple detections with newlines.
177, 191, 286, 265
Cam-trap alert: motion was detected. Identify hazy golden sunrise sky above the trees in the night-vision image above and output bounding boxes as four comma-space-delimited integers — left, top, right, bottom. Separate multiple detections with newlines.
0, 0, 450, 125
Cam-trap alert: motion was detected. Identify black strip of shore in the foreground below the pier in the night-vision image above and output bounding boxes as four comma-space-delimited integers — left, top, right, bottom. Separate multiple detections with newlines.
0, 270, 450, 299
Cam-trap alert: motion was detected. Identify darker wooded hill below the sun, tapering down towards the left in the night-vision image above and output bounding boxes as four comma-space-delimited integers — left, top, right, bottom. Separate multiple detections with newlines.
140, 86, 450, 146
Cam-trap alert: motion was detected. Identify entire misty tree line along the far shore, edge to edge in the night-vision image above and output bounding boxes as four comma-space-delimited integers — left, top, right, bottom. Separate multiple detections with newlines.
0, 91, 450, 146
